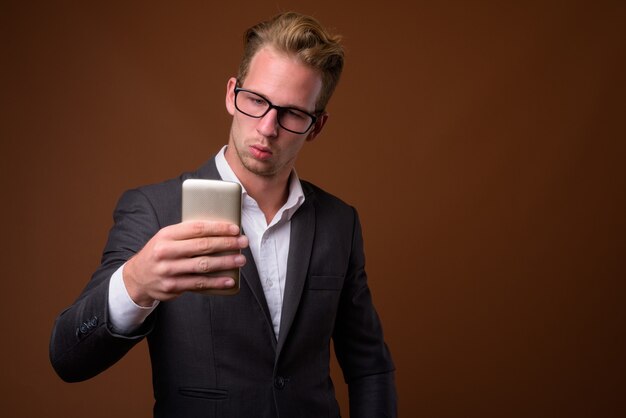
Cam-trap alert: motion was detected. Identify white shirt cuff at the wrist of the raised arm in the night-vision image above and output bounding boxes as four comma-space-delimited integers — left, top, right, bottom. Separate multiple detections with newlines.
108, 264, 159, 335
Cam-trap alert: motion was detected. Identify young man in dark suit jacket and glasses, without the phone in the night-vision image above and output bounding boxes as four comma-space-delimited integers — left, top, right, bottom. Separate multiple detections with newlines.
50, 13, 396, 418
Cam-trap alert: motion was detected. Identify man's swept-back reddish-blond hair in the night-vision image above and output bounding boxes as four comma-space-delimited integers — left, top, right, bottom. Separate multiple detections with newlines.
237, 12, 344, 112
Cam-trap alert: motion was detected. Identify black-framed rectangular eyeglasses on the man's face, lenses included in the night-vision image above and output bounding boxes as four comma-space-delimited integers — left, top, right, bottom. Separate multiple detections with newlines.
235, 87, 317, 134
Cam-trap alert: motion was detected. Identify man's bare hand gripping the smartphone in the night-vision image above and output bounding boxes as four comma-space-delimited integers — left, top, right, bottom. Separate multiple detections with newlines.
123, 221, 248, 306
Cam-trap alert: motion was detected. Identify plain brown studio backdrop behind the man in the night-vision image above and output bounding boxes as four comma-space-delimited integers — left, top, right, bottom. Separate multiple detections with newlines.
0, 0, 626, 417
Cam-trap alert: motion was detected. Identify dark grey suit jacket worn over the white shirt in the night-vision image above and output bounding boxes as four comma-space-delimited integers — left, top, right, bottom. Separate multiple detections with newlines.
50, 159, 396, 418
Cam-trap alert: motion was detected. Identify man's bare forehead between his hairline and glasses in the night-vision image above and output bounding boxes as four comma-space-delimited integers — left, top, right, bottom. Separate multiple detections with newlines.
243, 47, 322, 110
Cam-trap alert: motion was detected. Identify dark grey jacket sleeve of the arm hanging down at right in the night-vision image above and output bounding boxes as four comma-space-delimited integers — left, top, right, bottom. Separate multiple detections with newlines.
333, 211, 397, 418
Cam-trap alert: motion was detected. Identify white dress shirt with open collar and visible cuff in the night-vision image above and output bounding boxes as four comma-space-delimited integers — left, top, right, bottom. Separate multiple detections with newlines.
109, 146, 304, 339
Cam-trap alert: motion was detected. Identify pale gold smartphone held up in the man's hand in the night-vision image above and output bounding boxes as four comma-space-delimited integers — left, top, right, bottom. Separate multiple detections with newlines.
182, 179, 241, 295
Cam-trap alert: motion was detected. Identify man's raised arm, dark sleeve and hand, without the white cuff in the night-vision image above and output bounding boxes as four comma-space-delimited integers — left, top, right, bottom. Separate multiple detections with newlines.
50, 190, 247, 381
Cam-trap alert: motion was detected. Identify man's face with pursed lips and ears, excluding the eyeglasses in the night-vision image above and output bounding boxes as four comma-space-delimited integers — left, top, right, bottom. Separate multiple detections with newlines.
226, 47, 327, 181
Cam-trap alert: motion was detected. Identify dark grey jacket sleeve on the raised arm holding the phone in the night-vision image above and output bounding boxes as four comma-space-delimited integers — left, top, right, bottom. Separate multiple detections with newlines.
50, 190, 160, 382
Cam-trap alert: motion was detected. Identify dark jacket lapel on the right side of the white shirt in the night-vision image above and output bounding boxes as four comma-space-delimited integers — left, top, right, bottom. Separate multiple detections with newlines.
276, 196, 315, 356
